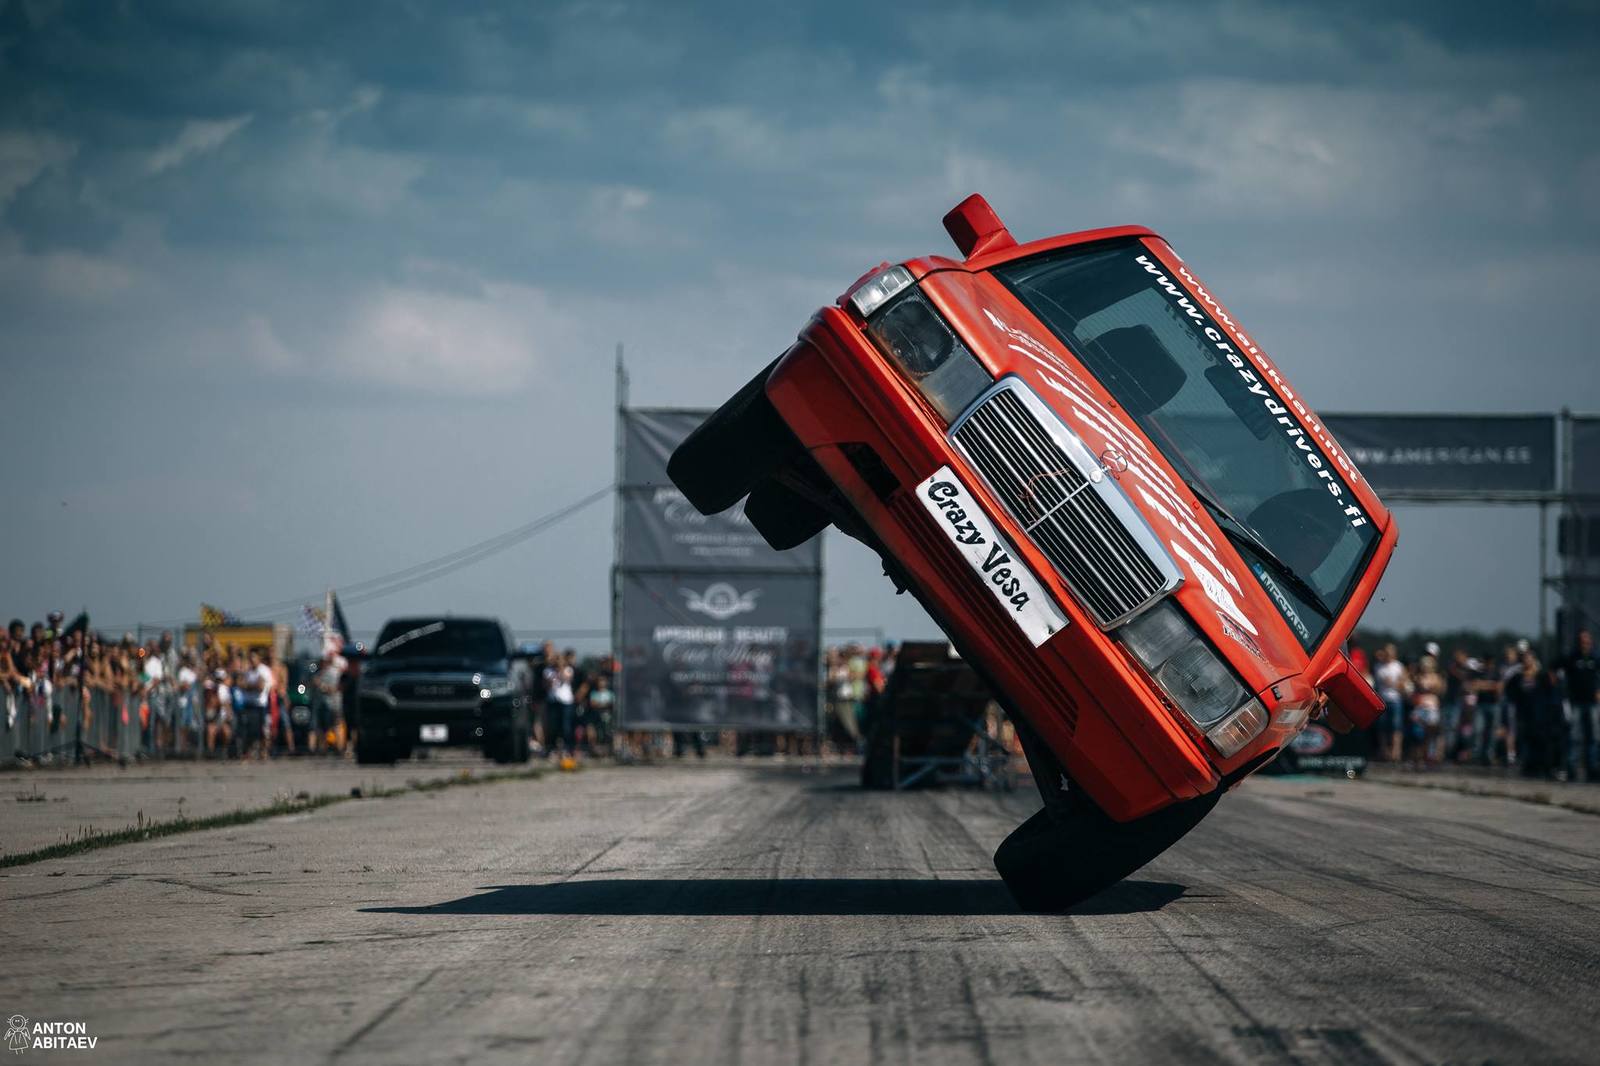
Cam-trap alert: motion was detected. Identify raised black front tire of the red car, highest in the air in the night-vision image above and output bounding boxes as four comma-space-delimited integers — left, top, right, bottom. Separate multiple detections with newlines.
667, 360, 800, 514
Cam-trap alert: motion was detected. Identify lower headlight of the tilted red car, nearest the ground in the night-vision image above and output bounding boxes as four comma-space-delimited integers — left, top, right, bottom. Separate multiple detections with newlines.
1118, 600, 1267, 755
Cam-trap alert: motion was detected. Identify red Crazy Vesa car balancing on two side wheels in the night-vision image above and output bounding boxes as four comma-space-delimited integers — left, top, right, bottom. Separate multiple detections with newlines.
669, 195, 1397, 909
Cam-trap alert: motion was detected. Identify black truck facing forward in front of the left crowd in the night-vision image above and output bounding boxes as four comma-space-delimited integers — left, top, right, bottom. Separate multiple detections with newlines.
355, 616, 533, 763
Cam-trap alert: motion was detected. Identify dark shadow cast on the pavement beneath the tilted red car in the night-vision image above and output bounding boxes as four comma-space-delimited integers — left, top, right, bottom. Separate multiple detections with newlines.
362, 877, 1184, 917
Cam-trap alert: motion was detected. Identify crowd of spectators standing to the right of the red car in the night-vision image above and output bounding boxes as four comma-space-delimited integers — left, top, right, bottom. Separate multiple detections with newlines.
1350, 631, 1600, 781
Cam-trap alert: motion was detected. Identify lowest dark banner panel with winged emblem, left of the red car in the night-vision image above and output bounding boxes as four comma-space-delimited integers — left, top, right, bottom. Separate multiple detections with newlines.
618, 571, 821, 731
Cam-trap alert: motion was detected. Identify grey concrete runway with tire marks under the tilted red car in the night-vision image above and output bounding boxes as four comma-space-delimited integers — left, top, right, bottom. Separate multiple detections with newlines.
0, 763, 1600, 1066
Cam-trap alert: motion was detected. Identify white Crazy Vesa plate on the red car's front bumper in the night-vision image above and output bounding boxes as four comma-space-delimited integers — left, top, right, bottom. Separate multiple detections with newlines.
917, 466, 1067, 648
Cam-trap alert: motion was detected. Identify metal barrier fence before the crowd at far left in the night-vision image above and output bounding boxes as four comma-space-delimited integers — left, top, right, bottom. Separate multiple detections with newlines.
0, 683, 200, 767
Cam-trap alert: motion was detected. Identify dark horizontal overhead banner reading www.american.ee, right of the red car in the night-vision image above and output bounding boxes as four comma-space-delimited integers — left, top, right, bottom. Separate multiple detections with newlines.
1323, 415, 1555, 495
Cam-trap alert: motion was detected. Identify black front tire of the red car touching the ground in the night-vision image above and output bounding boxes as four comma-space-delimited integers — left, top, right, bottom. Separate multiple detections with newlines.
995, 789, 1222, 914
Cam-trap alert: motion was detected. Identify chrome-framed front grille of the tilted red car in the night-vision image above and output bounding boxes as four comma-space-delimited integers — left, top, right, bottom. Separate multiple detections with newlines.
950, 379, 1178, 626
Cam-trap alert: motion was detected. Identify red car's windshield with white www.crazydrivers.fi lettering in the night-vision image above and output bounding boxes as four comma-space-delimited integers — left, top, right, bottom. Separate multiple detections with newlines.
994, 242, 1378, 650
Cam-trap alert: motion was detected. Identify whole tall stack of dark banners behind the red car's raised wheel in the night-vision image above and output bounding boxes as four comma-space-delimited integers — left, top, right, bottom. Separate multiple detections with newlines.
613, 408, 822, 731
